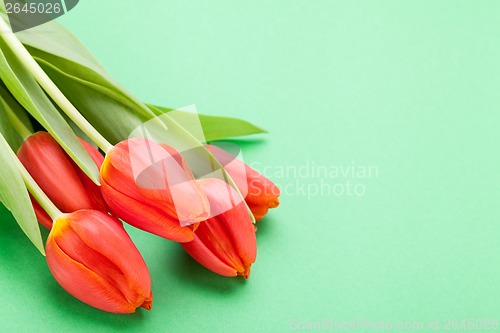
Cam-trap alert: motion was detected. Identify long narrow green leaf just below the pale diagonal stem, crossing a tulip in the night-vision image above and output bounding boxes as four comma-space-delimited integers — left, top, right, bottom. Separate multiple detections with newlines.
0, 40, 99, 183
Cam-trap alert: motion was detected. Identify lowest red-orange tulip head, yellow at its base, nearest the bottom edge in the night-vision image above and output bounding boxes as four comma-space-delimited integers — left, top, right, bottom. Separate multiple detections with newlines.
46, 210, 153, 313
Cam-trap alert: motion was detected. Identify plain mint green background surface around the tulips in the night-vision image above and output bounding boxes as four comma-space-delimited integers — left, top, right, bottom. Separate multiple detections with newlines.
0, 0, 500, 332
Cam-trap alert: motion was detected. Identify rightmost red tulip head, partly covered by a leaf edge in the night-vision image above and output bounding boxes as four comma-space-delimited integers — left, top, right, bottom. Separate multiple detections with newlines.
206, 145, 280, 221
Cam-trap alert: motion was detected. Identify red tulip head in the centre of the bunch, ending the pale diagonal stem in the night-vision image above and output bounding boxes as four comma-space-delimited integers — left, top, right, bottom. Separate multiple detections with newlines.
101, 138, 210, 242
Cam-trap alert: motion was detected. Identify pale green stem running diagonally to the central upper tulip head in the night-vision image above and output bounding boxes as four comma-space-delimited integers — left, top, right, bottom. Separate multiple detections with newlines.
0, 19, 113, 153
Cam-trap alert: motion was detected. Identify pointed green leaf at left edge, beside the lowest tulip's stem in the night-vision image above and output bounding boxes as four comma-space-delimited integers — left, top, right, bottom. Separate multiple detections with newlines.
0, 135, 45, 254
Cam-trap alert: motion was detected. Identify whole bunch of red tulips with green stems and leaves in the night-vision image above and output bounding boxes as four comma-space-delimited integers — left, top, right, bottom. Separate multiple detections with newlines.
0, 6, 279, 313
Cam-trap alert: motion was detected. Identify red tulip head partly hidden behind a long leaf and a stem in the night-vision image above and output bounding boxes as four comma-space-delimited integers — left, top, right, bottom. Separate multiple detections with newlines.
17, 132, 107, 230
